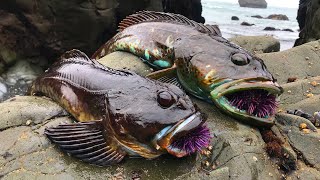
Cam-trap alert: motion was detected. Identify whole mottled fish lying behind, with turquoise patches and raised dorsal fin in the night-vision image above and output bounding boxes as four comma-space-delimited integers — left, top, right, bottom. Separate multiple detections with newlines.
92, 11, 282, 126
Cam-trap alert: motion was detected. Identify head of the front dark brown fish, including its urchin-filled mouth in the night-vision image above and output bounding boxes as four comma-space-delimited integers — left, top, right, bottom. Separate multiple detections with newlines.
109, 80, 210, 158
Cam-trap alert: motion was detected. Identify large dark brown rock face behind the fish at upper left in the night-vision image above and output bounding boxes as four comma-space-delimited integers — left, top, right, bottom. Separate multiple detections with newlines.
0, 0, 204, 63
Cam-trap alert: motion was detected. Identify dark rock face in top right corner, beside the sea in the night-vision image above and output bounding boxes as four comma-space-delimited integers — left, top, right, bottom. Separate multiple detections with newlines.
295, 0, 320, 46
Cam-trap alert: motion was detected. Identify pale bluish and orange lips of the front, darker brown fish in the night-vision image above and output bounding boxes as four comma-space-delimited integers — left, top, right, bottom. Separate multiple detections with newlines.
153, 111, 206, 157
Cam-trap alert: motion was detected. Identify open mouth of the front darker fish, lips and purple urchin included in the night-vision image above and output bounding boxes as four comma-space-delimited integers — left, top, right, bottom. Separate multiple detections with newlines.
152, 112, 211, 157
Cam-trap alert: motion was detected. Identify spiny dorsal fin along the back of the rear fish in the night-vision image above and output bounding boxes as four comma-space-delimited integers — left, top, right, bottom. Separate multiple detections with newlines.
119, 11, 221, 36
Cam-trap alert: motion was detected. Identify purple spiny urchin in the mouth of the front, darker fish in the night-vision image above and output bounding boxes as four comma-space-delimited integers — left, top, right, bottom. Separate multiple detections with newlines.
170, 126, 211, 154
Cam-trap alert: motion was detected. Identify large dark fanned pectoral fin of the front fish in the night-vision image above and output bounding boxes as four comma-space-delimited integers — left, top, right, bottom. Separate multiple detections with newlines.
45, 120, 126, 166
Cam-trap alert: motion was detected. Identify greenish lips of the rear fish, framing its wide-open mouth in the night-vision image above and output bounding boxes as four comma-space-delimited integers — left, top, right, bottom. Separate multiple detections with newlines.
210, 78, 283, 127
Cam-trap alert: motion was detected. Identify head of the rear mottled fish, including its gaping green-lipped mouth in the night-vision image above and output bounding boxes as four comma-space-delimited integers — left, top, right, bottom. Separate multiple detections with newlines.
177, 36, 283, 126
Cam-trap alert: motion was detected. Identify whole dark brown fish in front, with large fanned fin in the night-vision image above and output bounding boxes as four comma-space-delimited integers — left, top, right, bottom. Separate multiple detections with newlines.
30, 50, 209, 165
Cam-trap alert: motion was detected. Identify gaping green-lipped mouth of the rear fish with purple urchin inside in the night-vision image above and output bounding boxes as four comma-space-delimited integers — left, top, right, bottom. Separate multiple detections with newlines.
210, 78, 283, 126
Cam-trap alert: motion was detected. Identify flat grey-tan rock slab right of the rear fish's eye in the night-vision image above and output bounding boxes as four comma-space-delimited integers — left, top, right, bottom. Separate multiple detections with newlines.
258, 41, 320, 84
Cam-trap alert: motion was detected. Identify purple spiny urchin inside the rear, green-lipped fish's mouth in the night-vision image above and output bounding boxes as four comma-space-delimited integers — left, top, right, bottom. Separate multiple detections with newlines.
226, 89, 278, 118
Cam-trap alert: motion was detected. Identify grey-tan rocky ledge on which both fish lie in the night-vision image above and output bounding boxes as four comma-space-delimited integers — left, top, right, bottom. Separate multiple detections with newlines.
0, 41, 320, 180
